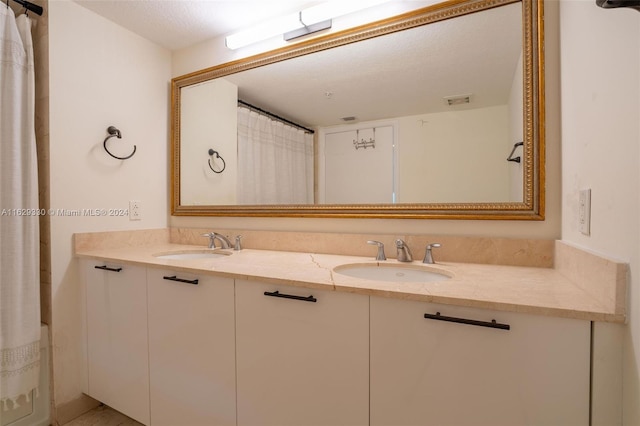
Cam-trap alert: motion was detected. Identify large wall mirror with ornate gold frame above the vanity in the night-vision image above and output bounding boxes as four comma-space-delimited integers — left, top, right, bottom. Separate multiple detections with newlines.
171, 0, 544, 220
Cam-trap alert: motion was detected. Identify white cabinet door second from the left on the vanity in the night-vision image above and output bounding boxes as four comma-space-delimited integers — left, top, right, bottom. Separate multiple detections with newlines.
147, 269, 236, 426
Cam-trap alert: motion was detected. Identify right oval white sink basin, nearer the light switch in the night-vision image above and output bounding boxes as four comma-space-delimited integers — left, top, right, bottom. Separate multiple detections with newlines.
333, 263, 451, 283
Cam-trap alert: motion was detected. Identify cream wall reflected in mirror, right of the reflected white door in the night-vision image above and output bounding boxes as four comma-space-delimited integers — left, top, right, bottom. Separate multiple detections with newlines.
398, 105, 512, 203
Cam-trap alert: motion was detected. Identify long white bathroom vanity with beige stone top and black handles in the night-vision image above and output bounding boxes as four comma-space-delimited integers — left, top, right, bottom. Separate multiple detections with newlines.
76, 231, 626, 426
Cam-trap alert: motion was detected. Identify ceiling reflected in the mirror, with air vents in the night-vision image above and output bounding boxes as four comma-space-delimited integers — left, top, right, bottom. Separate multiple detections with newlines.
208, 3, 522, 127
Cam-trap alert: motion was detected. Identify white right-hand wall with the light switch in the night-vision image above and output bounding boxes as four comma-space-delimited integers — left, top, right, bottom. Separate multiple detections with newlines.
560, 0, 640, 426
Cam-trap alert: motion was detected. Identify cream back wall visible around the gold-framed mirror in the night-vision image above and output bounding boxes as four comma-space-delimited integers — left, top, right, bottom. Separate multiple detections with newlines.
169, 1, 561, 239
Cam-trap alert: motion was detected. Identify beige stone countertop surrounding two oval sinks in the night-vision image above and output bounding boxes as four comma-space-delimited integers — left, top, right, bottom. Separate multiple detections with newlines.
76, 244, 625, 322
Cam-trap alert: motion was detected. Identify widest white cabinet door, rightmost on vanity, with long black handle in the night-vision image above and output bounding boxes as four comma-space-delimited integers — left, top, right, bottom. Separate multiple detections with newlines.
371, 297, 590, 426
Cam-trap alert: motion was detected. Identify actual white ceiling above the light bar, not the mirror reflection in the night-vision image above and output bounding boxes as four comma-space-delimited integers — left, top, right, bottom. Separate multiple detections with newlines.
74, 0, 320, 50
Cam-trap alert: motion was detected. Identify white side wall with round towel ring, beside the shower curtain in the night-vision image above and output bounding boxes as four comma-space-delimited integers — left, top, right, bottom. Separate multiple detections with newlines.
48, 1, 171, 406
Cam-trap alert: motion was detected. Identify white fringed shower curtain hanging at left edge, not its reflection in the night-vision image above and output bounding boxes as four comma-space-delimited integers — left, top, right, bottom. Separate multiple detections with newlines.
0, 4, 40, 410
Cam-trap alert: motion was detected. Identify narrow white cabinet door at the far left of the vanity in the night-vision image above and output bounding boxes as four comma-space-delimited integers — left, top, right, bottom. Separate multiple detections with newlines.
83, 261, 149, 425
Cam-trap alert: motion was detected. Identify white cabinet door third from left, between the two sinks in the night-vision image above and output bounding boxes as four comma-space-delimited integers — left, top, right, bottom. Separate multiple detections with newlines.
236, 281, 369, 426
